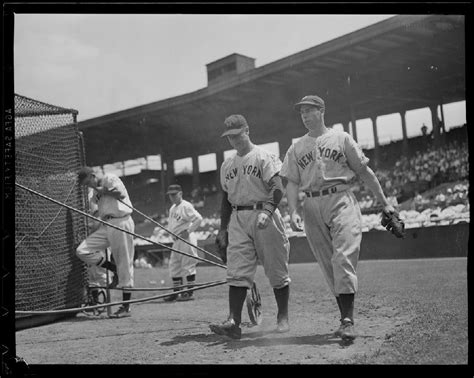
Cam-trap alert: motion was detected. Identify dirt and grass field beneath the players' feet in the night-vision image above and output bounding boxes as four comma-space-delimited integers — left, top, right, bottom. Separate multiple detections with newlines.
16, 258, 468, 365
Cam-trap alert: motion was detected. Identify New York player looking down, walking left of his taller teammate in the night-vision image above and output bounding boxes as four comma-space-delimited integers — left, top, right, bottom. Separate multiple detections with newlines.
210, 114, 290, 339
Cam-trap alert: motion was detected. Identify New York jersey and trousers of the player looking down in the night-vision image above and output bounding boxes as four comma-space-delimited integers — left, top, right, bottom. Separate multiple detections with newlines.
220, 146, 291, 289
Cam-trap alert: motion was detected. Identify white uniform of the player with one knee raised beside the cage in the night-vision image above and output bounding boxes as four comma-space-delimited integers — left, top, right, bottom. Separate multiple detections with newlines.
76, 173, 135, 288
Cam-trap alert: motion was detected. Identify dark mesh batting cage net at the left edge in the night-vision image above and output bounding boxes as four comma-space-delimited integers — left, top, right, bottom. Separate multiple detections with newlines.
15, 95, 87, 319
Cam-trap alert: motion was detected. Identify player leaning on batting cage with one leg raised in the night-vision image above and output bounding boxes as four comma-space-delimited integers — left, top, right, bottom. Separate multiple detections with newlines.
76, 167, 135, 317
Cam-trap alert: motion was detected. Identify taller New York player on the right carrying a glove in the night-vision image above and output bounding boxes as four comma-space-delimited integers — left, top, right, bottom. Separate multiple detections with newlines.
280, 95, 395, 341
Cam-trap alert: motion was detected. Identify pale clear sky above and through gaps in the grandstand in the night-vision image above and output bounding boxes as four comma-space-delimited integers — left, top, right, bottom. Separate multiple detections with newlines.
14, 14, 466, 174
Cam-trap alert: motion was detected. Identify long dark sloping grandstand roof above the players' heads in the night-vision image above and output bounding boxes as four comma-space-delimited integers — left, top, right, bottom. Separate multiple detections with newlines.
79, 15, 466, 165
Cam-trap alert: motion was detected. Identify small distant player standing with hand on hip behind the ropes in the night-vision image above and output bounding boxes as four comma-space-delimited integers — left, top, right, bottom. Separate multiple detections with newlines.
164, 185, 202, 302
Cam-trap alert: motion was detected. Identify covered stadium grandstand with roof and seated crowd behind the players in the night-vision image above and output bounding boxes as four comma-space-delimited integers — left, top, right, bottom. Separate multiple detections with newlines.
78, 15, 469, 245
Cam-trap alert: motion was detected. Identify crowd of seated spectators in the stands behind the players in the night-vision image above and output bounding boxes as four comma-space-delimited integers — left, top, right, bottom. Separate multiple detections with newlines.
136, 133, 469, 244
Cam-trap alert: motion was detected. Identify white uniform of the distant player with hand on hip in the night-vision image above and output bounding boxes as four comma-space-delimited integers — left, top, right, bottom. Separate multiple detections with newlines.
168, 199, 202, 278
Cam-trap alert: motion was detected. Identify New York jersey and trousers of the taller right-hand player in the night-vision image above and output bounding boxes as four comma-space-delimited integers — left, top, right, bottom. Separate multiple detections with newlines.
280, 129, 369, 295
